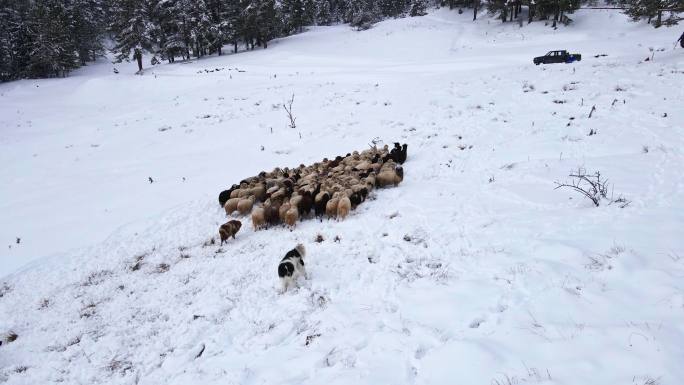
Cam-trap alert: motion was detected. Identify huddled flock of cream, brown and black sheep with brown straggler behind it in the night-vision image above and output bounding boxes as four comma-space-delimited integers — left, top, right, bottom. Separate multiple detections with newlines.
219, 143, 408, 244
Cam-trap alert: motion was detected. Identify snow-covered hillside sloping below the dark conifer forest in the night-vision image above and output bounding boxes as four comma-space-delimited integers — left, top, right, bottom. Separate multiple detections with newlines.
0, 6, 684, 385
